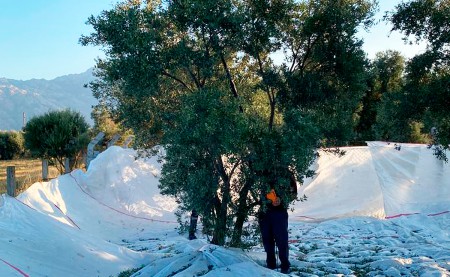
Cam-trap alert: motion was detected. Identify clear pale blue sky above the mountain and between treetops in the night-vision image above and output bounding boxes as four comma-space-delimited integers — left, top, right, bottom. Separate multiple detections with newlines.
0, 0, 423, 80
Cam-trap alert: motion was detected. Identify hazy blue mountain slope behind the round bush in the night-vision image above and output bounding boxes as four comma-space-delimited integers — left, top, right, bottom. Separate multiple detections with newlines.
0, 69, 98, 130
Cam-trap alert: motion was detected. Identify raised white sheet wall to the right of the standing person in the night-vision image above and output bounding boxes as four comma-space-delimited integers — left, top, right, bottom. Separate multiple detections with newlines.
293, 142, 450, 220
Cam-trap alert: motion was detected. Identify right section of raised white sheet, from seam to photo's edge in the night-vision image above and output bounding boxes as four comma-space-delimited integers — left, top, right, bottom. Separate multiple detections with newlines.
368, 142, 450, 217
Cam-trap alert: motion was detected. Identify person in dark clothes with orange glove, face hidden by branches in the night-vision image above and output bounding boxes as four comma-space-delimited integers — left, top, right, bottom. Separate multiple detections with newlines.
259, 172, 297, 273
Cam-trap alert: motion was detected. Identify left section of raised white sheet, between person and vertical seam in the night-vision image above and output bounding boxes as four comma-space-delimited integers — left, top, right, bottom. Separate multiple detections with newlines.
291, 147, 385, 220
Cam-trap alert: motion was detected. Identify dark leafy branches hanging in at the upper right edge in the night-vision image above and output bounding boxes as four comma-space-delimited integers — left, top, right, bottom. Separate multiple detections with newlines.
386, 0, 450, 159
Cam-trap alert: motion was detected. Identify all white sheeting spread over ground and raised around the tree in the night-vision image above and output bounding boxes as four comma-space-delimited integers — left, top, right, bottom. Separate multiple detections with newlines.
0, 144, 450, 277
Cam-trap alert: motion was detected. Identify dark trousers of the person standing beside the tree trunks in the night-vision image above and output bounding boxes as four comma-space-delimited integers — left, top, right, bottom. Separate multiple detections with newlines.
259, 209, 291, 270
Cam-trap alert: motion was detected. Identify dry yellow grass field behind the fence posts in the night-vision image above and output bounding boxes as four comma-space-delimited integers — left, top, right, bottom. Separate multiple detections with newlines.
0, 159, 59, 194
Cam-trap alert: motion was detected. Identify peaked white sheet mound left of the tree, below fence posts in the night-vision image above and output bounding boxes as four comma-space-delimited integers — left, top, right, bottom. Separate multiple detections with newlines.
17, 146, 178, 241
